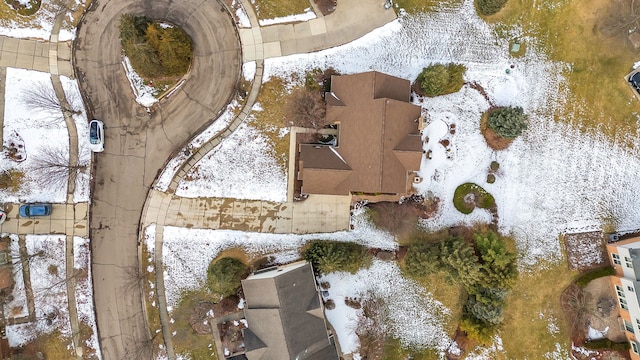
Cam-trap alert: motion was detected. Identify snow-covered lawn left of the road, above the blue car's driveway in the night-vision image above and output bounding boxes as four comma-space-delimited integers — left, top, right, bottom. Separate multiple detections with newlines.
0, 68, 91, 203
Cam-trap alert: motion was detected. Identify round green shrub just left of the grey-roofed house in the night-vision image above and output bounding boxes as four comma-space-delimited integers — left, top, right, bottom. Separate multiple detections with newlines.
207, 257, 248, 298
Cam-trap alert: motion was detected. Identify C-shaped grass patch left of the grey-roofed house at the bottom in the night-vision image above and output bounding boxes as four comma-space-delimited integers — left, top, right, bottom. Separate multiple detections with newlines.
170, 288, 218, 360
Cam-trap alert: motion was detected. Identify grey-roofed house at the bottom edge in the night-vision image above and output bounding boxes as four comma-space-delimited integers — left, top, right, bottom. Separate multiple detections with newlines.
242, 262, 338, 360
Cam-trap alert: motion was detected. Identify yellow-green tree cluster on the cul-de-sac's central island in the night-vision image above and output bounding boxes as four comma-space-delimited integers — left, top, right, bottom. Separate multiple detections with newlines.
120, 14, 193, 80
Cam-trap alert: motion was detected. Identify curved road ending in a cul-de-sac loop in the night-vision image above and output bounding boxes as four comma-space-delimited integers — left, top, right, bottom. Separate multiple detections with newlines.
74, 0, 242, 360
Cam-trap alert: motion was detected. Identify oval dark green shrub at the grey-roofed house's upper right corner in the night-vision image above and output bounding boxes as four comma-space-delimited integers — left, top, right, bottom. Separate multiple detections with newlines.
303, 240, 372, 274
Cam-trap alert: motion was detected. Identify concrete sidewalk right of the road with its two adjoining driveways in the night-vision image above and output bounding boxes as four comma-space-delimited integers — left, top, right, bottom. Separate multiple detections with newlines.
140, 0, 396, 360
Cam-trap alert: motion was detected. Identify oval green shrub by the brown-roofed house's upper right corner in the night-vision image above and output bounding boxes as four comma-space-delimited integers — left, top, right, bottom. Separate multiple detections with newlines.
416, 63, 467, 97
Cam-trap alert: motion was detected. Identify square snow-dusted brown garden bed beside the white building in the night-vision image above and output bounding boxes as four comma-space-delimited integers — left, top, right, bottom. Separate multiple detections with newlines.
564, 231, 609, 271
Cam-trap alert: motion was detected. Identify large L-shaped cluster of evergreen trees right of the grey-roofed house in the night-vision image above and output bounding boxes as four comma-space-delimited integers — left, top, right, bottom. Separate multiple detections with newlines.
405, 231, 518, 344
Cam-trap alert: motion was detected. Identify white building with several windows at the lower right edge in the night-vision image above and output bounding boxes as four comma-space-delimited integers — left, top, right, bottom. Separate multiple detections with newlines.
607, 237, 640, 360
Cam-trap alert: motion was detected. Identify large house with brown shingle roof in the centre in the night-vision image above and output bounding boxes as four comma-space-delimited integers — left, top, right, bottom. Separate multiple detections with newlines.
297, 71, 423, 200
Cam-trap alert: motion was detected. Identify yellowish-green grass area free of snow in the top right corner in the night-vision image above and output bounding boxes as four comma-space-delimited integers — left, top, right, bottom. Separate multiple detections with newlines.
486, 0, 640, 136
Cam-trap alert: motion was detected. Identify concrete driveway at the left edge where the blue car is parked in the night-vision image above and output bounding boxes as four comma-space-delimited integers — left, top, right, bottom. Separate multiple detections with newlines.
0, 203, 89, 238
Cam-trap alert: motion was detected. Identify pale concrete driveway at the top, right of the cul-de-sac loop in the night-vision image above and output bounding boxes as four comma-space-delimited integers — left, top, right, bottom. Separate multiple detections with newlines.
238, 0, 396, 61
